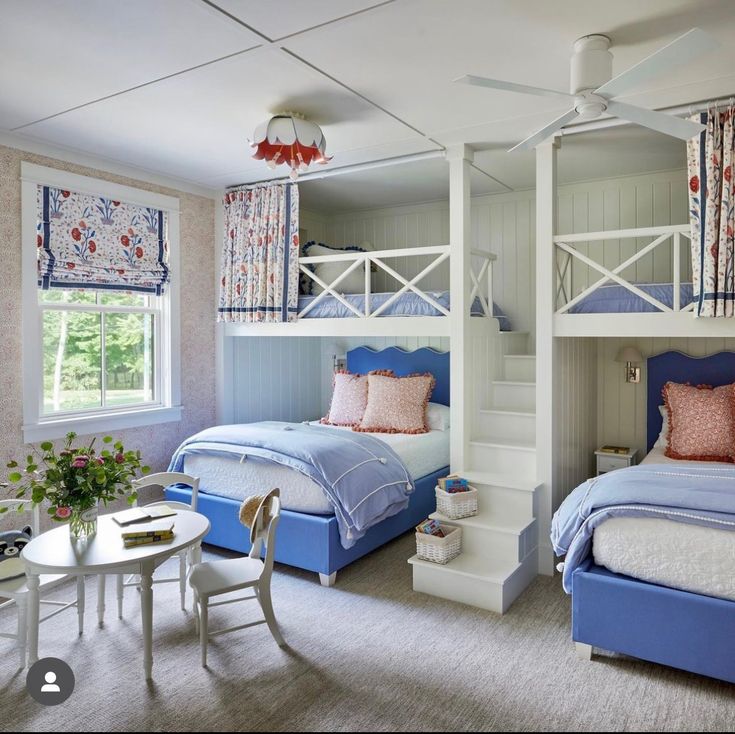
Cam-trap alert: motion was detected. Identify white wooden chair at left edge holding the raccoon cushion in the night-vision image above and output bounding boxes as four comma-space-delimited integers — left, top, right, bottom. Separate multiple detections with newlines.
0, 500, 84, 669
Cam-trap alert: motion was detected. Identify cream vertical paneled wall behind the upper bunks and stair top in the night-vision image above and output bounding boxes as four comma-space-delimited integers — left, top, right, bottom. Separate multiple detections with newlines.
318, 170, 689, 334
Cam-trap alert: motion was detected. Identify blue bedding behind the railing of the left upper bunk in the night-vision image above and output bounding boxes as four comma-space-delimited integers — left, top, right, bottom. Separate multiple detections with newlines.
299, 291, 511, 331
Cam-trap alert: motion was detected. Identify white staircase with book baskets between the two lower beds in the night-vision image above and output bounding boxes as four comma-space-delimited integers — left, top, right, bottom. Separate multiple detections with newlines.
409, 332, 539, 613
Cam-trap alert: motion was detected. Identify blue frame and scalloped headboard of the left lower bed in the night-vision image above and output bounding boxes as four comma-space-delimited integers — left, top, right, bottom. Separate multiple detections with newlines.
165, 347, 449, 577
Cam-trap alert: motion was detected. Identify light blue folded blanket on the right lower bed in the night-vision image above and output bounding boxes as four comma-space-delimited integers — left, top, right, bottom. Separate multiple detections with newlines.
551, 464, 735, 594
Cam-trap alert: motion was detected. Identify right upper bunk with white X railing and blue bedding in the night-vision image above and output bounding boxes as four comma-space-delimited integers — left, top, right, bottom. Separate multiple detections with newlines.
553, 223, 733, 337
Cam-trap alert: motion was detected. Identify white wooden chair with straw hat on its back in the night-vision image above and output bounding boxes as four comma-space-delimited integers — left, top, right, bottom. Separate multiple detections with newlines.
189, 489, 286, 667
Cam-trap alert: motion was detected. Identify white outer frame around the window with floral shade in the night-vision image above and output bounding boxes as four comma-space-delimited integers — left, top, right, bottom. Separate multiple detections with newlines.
21, 161, 181, 443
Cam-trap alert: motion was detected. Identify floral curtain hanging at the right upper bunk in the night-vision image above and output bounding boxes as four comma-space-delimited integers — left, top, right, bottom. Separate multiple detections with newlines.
687, 107, 735, 317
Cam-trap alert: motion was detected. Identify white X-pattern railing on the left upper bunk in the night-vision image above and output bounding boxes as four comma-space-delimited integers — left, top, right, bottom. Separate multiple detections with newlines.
298, 245, 496, 319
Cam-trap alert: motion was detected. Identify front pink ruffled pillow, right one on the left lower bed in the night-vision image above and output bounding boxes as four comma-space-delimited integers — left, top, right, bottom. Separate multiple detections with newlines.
355, 372, 435, 433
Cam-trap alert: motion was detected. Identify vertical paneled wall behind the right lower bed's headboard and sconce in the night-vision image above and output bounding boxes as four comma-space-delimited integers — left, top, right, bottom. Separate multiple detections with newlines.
596, 337, 735, 459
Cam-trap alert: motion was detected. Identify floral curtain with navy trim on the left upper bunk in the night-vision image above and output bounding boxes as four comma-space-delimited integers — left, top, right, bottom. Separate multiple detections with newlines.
217, 183, 299, 322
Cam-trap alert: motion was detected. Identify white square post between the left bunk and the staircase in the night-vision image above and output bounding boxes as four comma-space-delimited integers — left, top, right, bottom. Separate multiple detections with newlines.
447, 144, 474, 471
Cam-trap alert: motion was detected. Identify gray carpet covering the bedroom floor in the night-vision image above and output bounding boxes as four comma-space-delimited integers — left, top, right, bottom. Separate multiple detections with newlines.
0, 535, 735, 731
